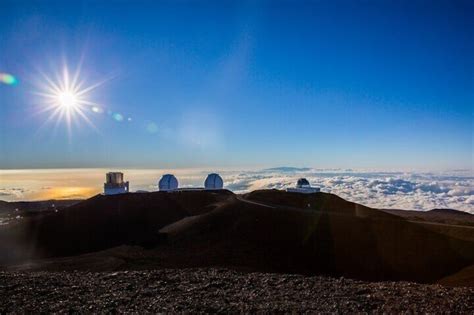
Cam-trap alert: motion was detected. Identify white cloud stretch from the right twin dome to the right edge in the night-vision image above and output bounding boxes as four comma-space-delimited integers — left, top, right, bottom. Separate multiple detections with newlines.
223, 167, 474, 214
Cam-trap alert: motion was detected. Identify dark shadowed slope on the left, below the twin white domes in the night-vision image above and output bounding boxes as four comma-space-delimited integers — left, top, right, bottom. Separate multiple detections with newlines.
0, 191, 231, 263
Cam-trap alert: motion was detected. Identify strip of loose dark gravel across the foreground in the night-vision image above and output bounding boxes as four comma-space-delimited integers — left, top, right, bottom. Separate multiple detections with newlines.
0, 269, 474, 314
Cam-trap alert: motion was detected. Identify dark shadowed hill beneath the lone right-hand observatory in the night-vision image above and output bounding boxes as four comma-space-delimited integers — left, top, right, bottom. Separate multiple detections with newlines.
162, 191, 474, 282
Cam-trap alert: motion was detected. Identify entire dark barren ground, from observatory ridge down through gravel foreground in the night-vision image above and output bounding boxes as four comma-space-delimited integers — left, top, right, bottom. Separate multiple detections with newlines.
0, 190, 474, 313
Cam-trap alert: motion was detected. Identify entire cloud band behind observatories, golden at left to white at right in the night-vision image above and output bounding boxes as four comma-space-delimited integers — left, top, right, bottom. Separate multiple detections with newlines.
0, 167, 474, 214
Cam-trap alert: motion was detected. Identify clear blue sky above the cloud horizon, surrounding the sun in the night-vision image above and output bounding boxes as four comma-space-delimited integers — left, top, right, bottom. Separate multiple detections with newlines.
0, 1, 474, 169
